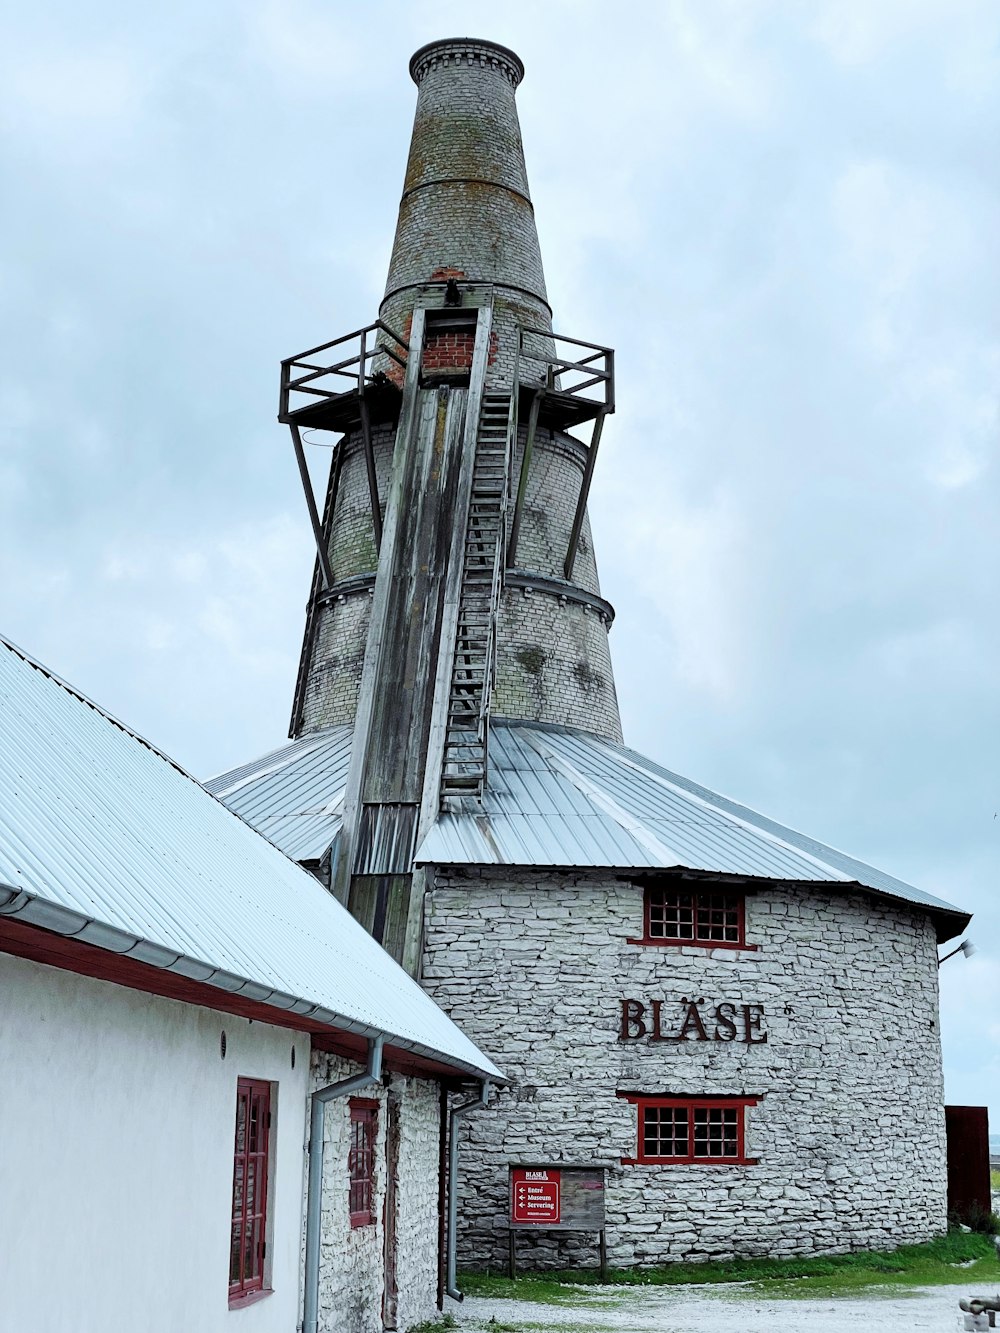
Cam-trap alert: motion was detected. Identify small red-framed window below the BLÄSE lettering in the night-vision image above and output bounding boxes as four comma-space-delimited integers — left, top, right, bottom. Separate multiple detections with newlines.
619, 1093, 757, 1166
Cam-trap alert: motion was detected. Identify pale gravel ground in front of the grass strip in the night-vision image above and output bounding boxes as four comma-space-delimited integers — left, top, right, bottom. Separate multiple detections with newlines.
447, 1282, 992, 1333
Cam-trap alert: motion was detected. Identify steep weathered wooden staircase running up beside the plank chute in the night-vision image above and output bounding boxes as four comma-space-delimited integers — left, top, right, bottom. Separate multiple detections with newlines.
441, 392, 515, 800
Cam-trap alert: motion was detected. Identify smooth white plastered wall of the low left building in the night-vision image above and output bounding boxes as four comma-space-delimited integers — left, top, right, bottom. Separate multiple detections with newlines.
0, 954, 309, 1333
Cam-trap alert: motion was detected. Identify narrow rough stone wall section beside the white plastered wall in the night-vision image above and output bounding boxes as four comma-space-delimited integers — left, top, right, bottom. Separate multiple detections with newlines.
311, 1052, 440, 1333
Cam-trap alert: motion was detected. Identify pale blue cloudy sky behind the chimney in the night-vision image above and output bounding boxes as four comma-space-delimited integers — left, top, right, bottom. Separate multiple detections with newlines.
0, 0, 1000, 1132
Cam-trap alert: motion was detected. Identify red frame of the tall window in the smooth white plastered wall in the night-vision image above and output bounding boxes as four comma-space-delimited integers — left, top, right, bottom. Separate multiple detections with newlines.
229, 1077, 273, 1309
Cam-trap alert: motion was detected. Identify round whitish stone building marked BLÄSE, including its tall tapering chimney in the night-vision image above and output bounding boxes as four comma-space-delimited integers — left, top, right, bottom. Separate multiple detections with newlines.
211, 39, 968, 1266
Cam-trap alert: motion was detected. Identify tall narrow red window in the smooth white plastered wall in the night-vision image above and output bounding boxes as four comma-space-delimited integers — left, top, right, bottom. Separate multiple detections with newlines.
229, 1078, 271, 1305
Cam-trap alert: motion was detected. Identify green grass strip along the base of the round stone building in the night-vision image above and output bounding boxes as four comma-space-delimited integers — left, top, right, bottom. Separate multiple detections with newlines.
459, 1230, 1000, 1306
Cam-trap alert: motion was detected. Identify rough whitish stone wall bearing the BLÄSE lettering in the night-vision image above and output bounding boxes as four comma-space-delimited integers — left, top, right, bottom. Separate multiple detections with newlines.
423, 870, 945, 1268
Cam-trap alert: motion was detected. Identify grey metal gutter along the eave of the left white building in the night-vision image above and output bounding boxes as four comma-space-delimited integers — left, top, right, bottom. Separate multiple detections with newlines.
0, 885, 503, 1081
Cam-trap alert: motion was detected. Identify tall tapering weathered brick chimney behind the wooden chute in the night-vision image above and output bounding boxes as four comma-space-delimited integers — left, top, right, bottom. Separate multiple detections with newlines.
291, 37, 621, 740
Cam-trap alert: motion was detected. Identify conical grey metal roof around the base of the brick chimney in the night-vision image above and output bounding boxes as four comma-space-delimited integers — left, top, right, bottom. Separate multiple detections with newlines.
212, 718, 968, 930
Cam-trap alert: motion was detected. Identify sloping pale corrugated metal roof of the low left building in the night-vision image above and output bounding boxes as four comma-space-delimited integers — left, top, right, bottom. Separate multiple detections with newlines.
0, 640, 501, 1077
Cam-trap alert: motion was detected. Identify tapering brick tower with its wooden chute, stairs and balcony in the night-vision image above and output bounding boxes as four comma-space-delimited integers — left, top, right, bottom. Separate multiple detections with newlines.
281, 39, 621, 965
